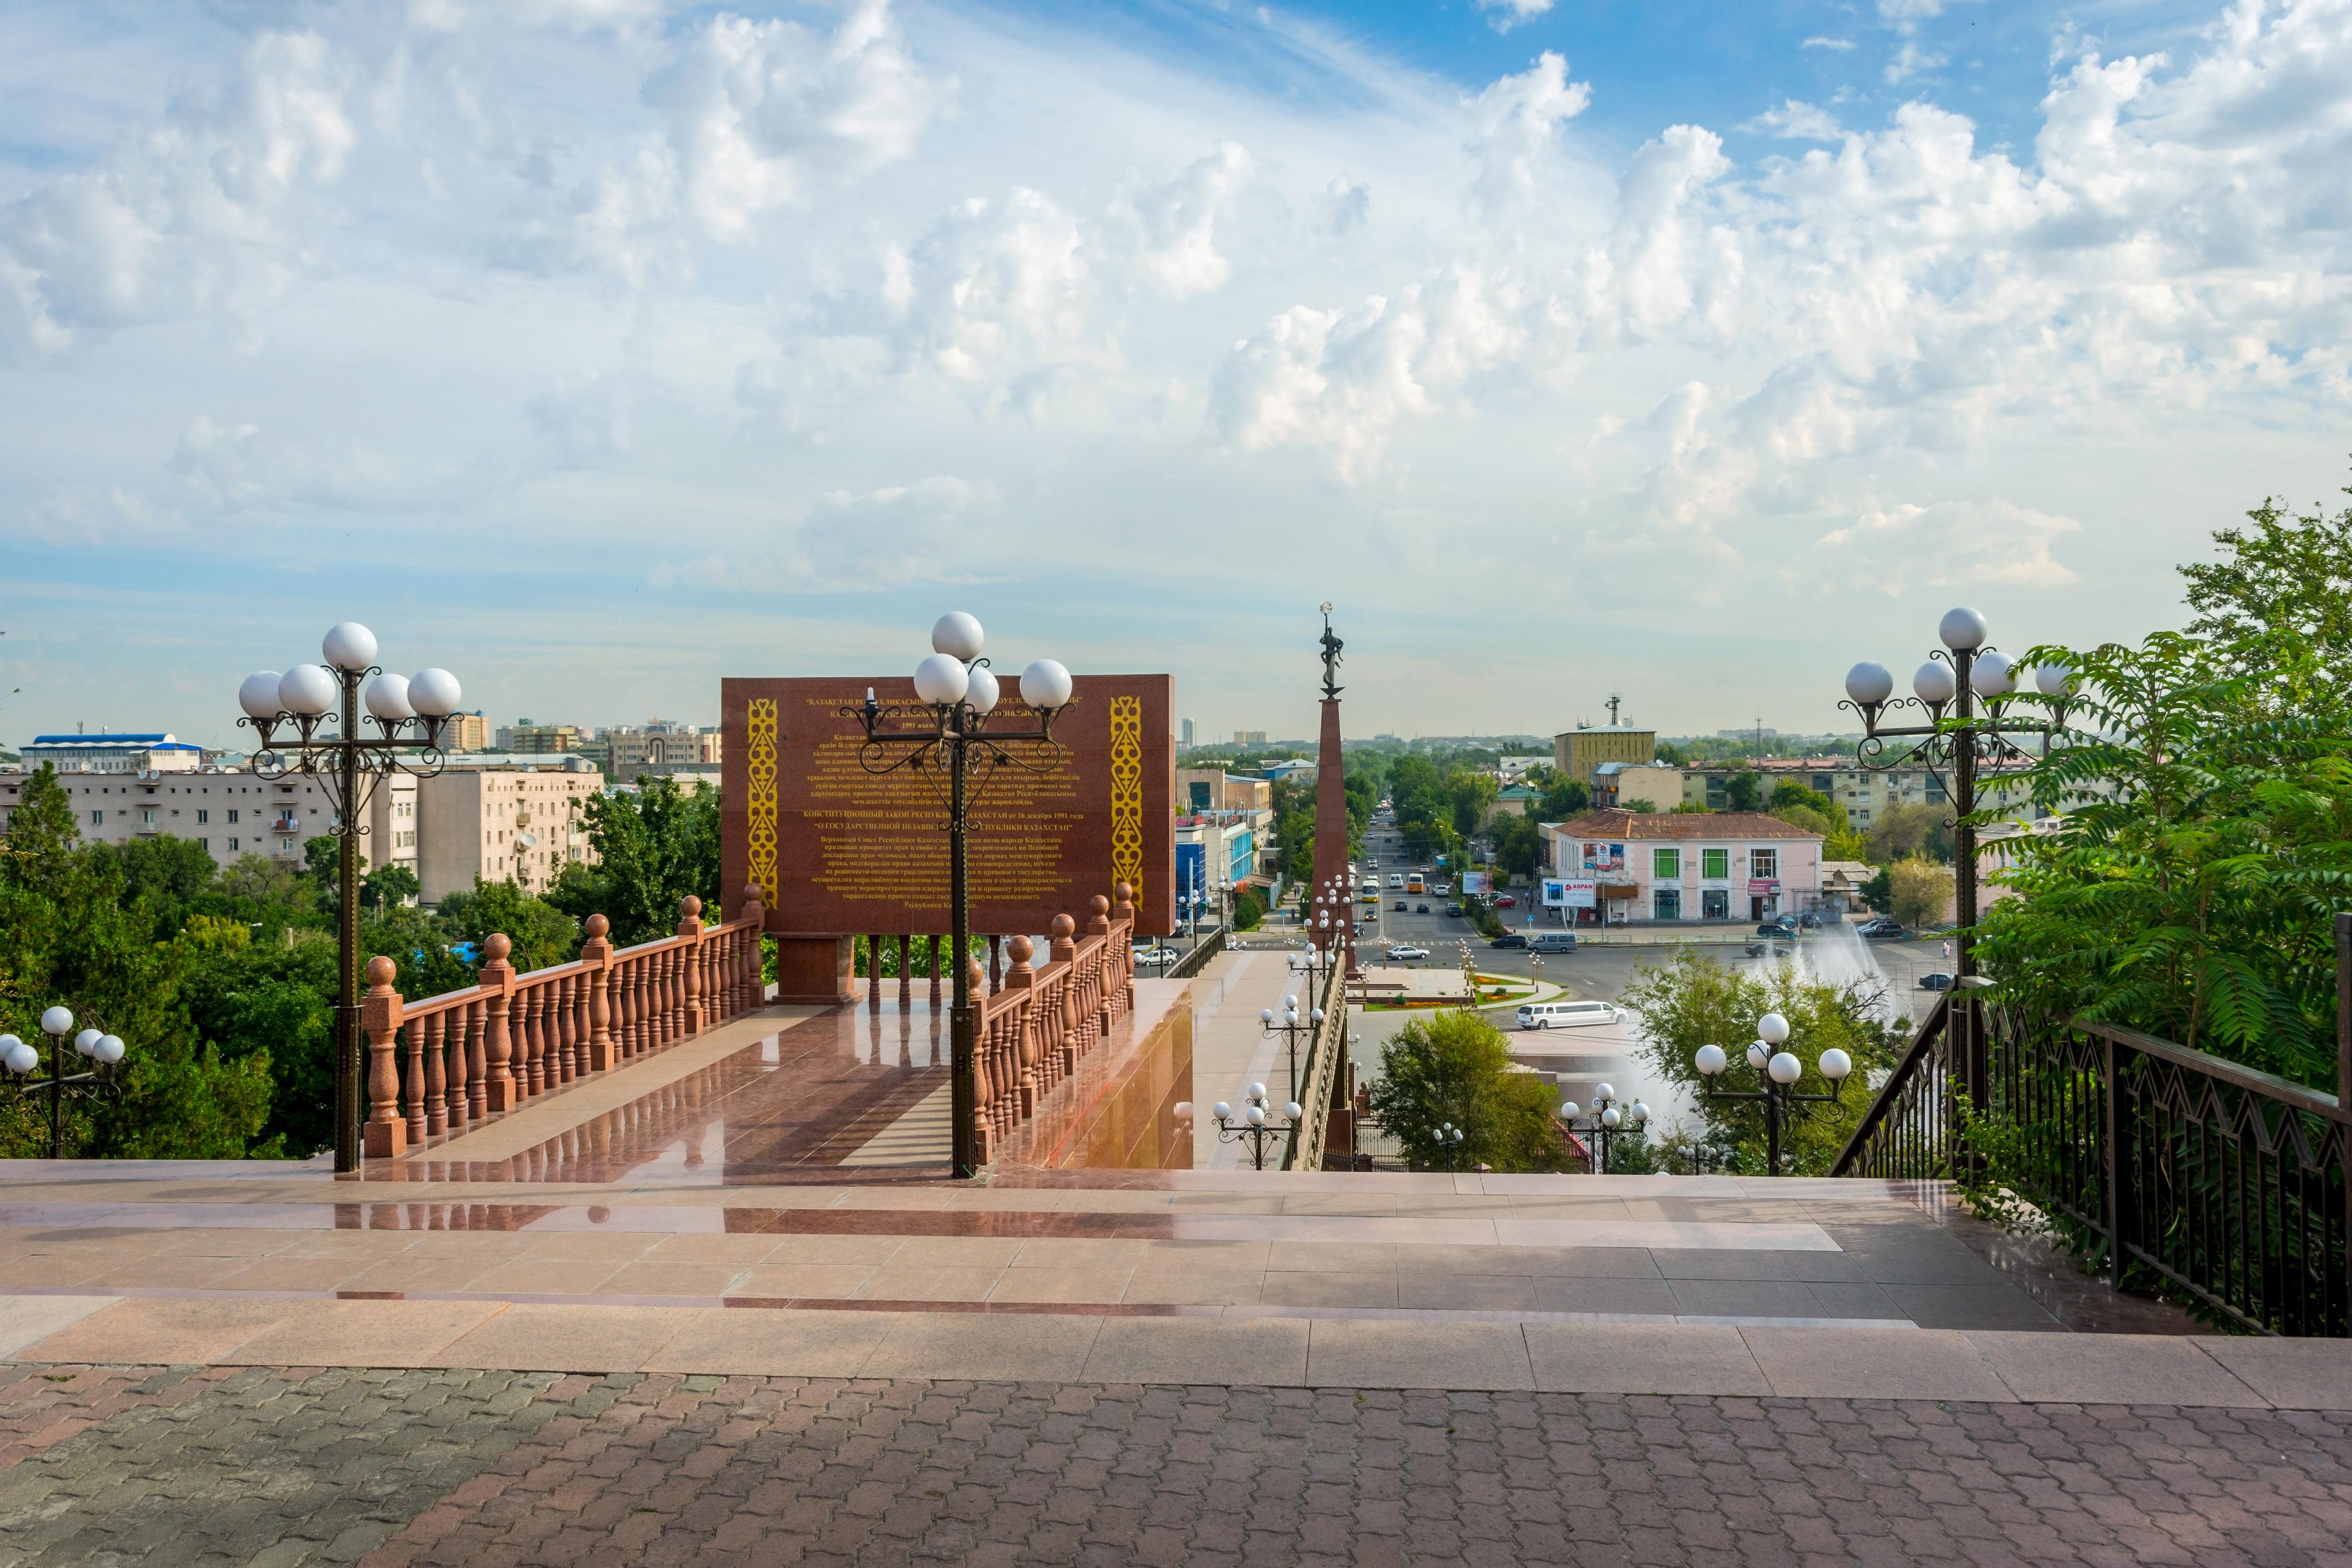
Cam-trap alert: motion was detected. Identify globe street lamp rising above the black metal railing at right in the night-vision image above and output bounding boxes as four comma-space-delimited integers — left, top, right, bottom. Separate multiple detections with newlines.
1839, 606, 2074, 976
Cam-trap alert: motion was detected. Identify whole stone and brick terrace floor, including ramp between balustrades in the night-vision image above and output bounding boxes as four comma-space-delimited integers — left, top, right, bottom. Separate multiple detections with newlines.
0, 992, 2352, 1568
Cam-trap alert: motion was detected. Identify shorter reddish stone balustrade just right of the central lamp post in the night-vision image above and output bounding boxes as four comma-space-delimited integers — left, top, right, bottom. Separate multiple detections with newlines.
969, 882, 1136, 1163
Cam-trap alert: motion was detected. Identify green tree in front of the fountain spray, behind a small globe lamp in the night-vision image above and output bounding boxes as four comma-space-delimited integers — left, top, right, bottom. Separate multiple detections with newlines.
1621, 948, 1910, 1175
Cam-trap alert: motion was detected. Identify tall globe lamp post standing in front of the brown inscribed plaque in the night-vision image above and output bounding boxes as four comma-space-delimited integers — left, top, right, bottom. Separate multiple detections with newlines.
840, 611, 1070, 1180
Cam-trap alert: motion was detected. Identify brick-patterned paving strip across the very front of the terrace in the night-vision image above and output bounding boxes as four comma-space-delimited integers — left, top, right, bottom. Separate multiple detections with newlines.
0, 1366, 2352, 1568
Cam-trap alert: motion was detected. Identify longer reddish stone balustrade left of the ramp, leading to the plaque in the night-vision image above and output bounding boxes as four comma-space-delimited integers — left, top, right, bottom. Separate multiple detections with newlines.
362, 898, 767, 1159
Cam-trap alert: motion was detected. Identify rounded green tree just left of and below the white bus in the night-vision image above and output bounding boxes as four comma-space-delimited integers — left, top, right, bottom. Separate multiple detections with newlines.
1371, 1011, 1566, 1171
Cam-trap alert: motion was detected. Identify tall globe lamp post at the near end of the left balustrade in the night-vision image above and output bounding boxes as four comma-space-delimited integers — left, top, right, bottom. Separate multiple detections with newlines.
238, 620, 461, 1173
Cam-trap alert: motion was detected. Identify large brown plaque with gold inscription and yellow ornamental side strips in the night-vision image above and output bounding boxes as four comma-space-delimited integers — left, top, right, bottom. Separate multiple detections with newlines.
720, 675, 1176, 936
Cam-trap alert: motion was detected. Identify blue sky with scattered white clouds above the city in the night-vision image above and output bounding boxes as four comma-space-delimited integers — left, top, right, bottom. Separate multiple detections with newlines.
0, 0, 2352, 745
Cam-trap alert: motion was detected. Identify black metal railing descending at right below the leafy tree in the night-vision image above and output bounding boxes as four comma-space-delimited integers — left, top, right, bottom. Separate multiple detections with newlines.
1830, 997, 2352, 1338
